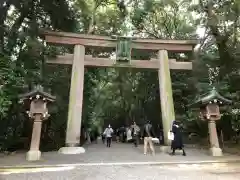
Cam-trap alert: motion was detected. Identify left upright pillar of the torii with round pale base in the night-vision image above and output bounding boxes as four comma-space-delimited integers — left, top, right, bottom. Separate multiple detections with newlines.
59, 45, 85, 154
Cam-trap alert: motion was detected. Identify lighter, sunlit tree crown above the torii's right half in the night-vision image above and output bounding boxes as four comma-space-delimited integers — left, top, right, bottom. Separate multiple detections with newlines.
132, 0, 195, 39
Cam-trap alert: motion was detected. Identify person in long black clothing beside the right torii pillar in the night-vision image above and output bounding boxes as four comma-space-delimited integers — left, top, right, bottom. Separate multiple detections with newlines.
171, 121, 186, 156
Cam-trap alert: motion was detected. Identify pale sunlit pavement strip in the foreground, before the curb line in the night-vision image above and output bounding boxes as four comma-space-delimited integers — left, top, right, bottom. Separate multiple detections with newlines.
0, 164, 240, 180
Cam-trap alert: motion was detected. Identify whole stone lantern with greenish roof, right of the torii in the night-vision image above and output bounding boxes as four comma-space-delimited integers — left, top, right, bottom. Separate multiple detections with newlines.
191, 88, 232, 156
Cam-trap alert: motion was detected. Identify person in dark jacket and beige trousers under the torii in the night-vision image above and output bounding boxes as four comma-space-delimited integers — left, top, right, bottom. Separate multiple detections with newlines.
142, 121, 155, 155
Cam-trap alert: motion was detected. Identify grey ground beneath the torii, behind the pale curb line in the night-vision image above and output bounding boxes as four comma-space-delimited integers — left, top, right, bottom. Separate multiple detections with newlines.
0, 143, 240, 166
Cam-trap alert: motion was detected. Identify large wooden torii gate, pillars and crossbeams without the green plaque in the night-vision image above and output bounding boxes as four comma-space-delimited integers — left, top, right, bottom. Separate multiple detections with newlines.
44, 31, 197, 154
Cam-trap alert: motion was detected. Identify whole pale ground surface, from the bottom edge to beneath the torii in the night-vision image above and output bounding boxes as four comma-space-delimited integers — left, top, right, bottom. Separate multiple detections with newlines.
0, 144, 240, 180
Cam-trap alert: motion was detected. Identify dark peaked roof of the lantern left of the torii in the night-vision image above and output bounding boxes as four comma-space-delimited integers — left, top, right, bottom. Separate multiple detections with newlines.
19, 85, 56, 102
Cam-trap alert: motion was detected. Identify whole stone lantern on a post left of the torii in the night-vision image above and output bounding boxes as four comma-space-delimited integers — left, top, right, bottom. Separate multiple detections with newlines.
19, 86, 56, 161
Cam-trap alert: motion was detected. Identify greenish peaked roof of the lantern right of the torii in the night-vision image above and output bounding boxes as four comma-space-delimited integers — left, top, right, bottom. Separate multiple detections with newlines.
190, 87, 232, 106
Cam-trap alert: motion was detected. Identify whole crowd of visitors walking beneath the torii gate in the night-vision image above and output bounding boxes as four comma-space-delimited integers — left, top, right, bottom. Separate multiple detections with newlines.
102, 121, 186, 156
